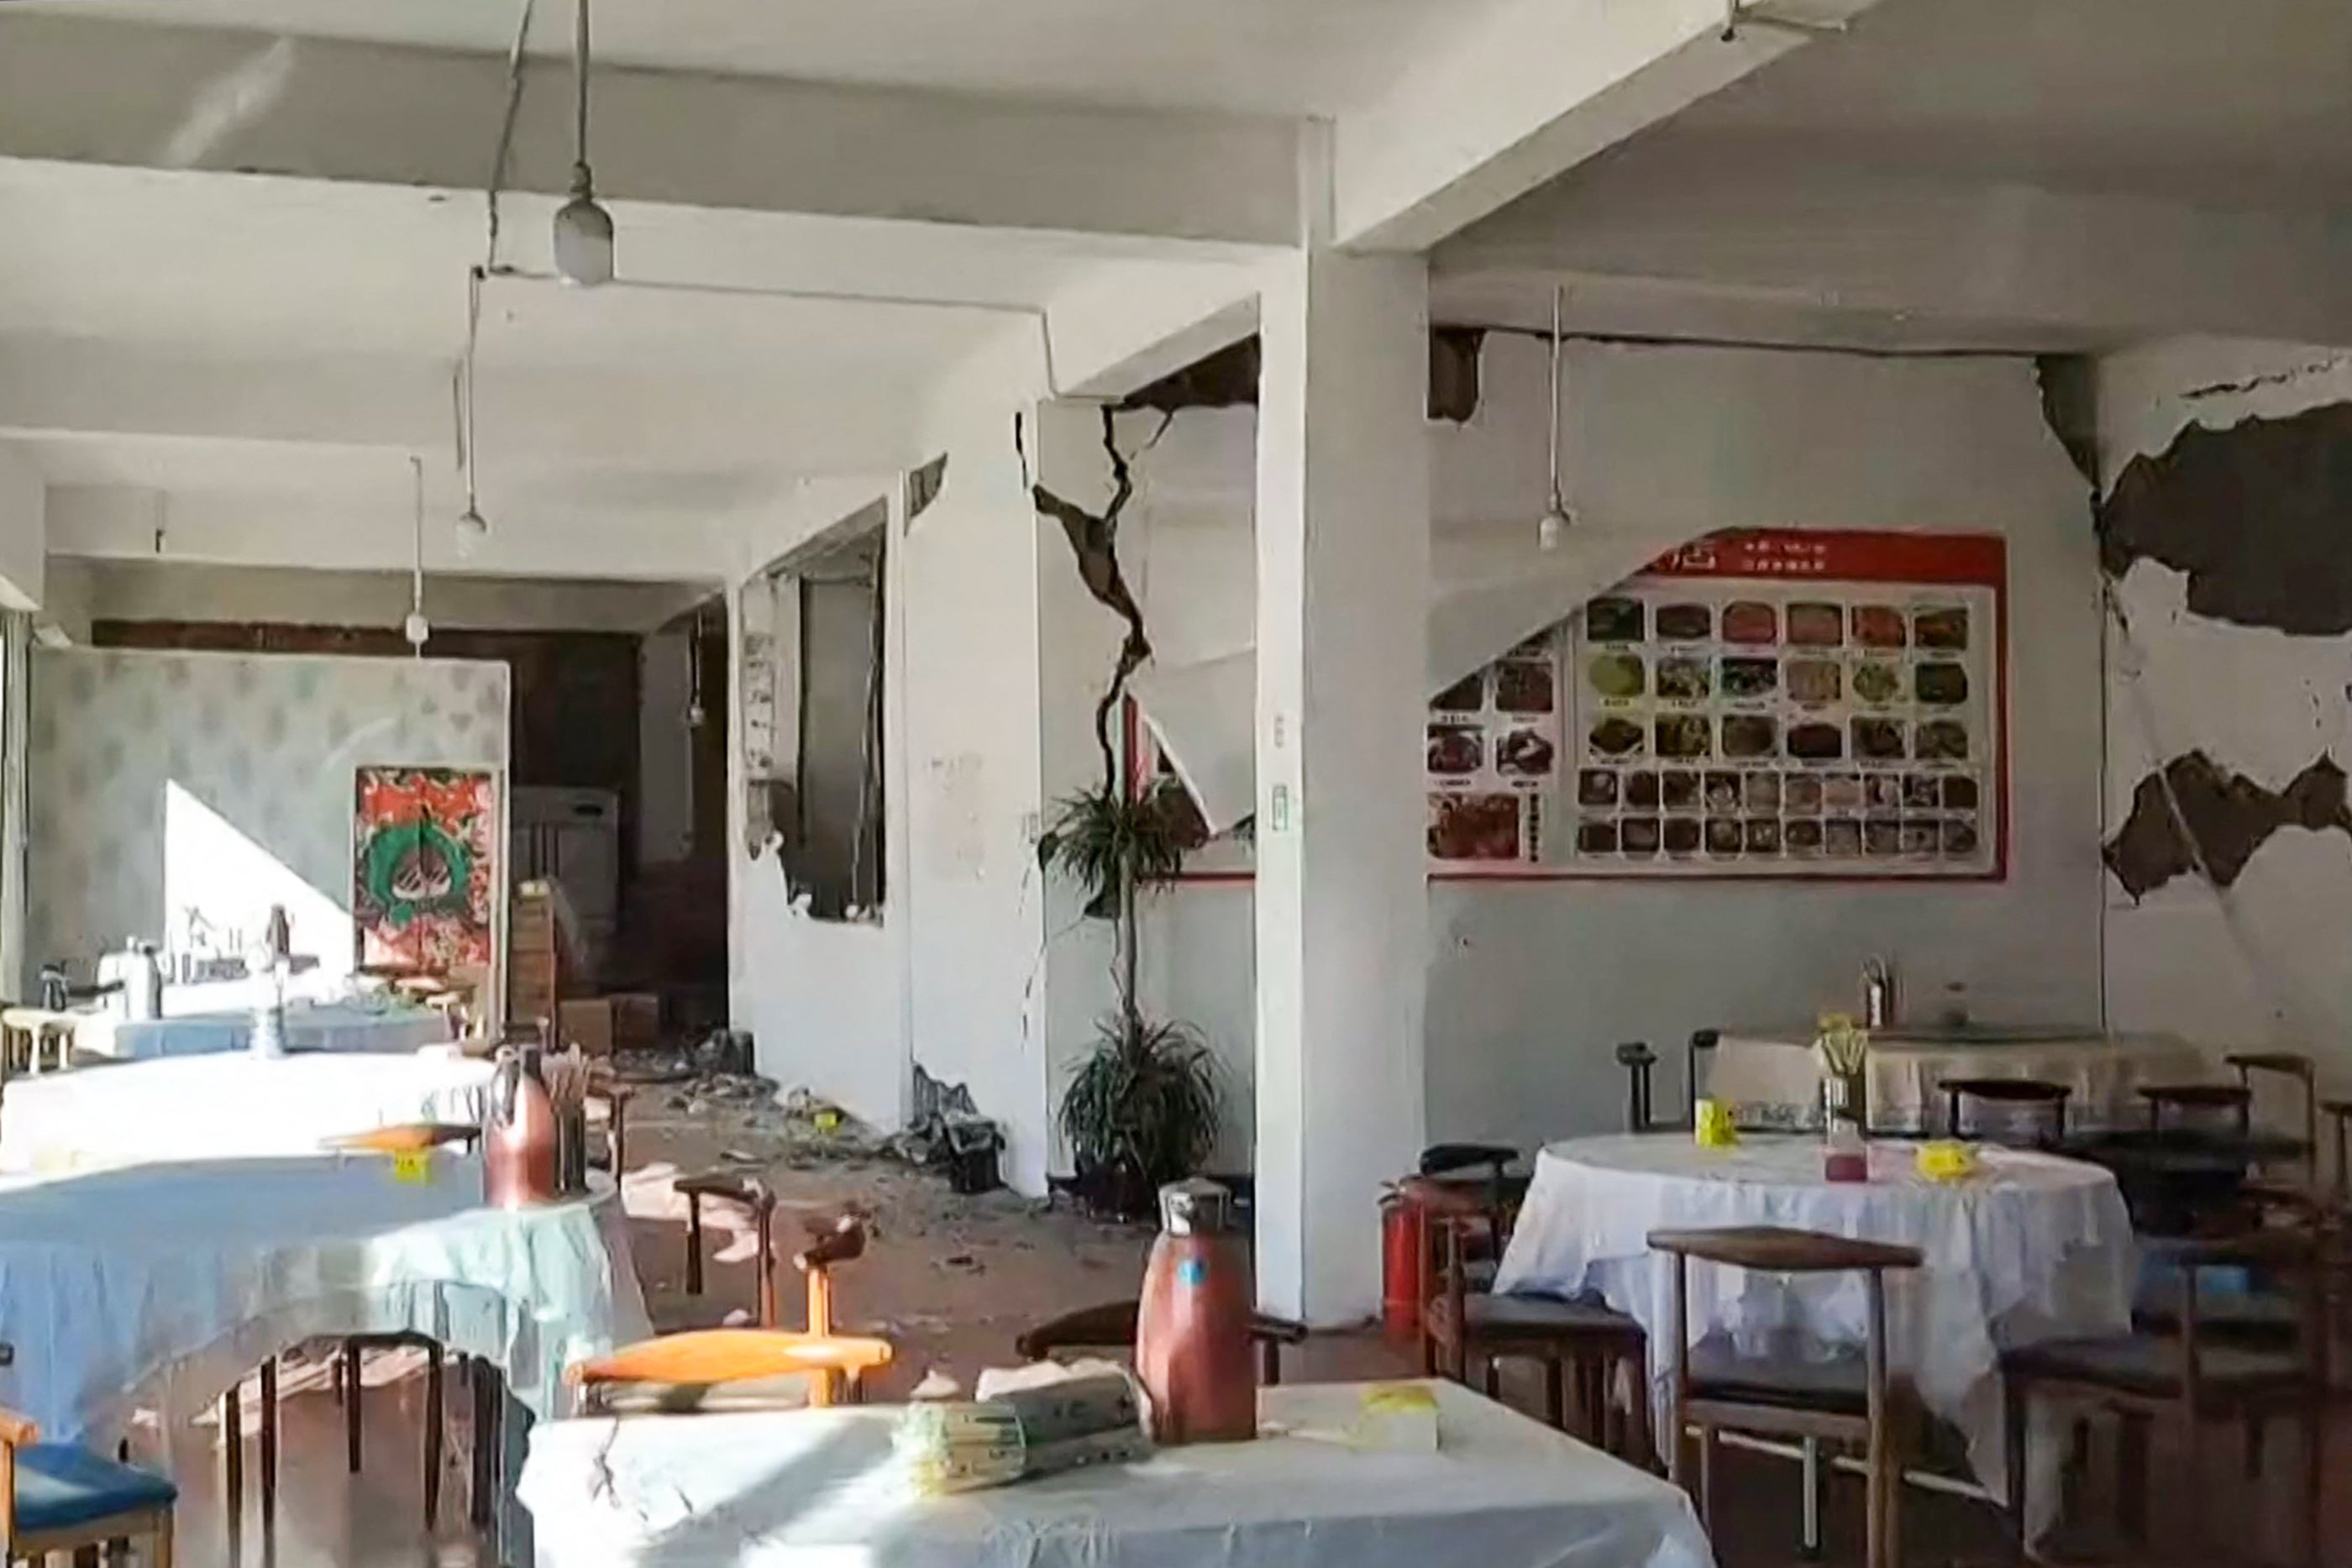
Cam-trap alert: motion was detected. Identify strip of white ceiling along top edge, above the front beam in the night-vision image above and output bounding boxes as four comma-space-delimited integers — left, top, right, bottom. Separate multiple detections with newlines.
17, 0, 1494, 115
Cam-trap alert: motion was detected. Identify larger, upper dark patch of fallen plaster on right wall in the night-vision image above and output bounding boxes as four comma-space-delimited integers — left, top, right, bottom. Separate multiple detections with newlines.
2098, 404, 2352, 637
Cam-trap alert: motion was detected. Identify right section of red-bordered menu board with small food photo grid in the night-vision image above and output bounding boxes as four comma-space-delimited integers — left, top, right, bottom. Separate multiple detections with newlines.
1562, 532, 2006, 877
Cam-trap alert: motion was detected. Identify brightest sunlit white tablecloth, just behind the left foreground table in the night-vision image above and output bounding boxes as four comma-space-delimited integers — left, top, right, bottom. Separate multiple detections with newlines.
0, 1048, 491, 1171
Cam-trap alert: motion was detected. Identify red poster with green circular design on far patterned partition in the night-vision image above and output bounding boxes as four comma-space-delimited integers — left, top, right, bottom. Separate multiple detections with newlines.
350, 767, 499, 973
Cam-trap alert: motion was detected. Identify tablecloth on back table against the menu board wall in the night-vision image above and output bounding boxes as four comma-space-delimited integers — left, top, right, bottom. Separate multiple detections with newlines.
1705, 1030, 2213, 1130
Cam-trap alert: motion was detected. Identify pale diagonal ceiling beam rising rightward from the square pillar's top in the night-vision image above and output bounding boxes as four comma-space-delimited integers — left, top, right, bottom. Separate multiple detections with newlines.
1331, 0, 1877, 252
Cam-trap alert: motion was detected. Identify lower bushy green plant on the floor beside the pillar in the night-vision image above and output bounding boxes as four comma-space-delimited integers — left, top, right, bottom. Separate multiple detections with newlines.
1061, 1009, 1223, 1218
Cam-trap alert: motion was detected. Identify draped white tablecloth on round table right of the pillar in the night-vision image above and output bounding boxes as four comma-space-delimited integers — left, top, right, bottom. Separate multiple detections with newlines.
1496, 1133, 2135, 1502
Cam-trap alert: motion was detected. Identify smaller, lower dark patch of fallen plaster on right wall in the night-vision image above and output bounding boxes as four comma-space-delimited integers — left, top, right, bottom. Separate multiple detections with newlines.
2103, 753, 2352, 900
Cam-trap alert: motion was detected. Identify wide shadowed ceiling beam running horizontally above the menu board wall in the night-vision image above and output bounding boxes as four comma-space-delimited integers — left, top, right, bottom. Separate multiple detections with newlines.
1432, 157, 2352, 343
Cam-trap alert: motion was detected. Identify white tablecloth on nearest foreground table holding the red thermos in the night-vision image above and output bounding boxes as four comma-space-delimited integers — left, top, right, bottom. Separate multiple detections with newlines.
520, 1385, 1712, 1568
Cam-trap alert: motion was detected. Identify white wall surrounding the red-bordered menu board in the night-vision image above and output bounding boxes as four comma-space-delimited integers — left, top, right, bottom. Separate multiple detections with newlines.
1047, 338, 2103, 1156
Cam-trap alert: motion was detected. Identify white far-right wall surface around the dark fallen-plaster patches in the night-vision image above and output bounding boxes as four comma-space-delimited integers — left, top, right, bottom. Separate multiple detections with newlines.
2098, 338, 2352, 1093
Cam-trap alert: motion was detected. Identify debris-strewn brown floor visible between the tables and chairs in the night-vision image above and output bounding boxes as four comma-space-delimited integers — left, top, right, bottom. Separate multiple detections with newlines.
156, 1117, 2352, 1568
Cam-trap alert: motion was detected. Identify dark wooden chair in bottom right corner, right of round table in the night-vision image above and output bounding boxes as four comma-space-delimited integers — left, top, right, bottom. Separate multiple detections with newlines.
2002, 1227, 2328, 1568
